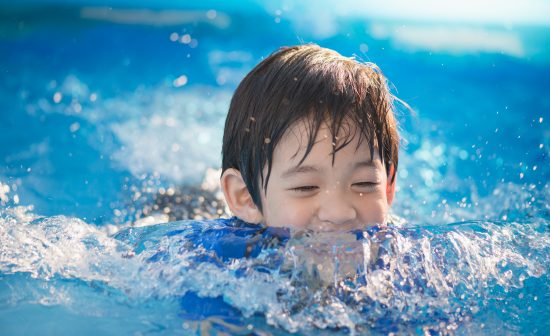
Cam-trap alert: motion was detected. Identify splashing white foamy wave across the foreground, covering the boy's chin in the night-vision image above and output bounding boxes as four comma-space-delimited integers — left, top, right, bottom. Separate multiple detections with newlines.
0, 202, 550, 334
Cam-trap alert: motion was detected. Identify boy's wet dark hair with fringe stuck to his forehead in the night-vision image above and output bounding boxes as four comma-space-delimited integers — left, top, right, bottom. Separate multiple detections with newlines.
222, 44, 399, 210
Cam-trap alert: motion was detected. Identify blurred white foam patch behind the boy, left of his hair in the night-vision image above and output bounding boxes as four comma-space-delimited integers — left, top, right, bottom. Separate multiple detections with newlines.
35, 75, 231, 183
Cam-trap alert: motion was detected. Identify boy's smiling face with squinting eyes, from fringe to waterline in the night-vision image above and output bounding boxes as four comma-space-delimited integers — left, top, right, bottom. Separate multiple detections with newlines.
261, 119, 394, 231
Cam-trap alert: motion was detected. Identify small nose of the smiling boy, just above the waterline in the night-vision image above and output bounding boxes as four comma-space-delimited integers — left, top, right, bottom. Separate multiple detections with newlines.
318, 192, 357, 225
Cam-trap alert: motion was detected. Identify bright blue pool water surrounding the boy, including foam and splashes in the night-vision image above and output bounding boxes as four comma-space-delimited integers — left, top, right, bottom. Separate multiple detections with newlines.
0, 1, 550, 335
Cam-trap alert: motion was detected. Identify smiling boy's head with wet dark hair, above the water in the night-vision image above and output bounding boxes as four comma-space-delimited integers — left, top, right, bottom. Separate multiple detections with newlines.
221, 45, 399, 231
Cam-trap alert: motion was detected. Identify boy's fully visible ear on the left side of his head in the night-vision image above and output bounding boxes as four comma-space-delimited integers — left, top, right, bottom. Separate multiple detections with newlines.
220, 168, 263, 224
